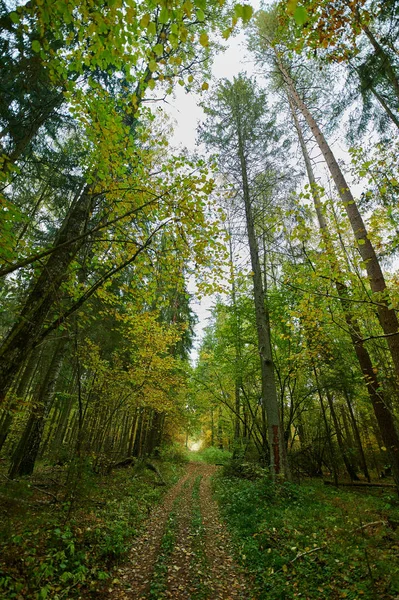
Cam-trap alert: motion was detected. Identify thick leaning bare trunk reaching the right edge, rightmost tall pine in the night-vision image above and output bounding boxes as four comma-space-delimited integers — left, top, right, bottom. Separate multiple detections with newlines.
275, 50, 399, 377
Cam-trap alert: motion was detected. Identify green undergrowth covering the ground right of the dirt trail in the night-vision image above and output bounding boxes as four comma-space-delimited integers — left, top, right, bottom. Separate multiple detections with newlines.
214, 475, 399, 600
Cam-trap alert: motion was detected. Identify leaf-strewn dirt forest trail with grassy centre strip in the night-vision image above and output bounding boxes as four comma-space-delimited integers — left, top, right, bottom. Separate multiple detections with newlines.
108, 463, 254, 600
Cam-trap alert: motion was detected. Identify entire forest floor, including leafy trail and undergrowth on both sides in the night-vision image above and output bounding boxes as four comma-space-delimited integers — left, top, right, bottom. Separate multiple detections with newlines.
0, 449, 399, 600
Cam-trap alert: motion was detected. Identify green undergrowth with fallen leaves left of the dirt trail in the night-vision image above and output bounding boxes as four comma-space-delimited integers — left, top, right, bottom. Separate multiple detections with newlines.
0, 461, 182, 600
